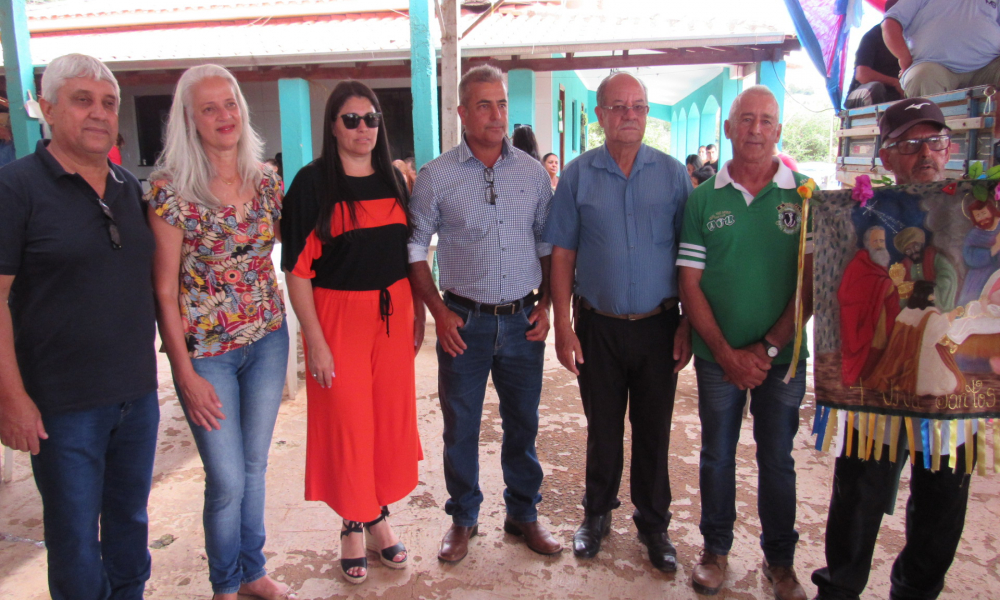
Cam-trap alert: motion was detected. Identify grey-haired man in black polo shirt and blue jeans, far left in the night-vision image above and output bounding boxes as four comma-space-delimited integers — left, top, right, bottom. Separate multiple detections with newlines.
0, 54, 159, 600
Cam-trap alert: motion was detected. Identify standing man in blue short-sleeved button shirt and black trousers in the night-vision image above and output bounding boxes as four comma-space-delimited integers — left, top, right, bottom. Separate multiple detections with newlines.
543, 73, 691, 572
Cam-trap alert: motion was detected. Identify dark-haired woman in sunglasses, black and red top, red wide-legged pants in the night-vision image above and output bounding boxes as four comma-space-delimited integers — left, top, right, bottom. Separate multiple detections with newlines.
281, 81, 424, 583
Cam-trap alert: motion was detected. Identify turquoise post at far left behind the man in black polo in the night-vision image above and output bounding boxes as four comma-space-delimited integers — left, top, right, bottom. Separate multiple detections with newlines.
0, 0, 42, 158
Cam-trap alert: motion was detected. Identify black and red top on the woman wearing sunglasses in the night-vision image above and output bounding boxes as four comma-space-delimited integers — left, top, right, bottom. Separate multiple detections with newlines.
281, 162, 409, 291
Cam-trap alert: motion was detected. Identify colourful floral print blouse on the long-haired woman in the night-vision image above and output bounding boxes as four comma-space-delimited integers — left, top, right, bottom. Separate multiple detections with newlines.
145, 168, 285, 358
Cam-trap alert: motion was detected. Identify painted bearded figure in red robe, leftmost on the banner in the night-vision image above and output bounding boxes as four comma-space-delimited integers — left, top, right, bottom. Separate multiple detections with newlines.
837, 225, 900, 386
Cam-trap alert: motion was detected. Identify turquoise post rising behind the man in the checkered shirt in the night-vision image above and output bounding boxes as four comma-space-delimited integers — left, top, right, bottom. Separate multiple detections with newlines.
410, 0, 441, 169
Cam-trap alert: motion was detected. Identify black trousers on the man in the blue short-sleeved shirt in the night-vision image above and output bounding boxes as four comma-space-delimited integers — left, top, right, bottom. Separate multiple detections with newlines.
576, 307, 680, 533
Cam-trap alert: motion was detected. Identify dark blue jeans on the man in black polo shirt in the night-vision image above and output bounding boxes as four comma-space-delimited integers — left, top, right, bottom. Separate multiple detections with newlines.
31, 392, 160, 600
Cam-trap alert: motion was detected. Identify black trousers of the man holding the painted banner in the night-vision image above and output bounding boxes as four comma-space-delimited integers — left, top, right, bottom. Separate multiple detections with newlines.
812, 428, 975, 600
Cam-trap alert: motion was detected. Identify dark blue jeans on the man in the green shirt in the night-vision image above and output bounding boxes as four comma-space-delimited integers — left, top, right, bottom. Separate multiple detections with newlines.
694, 358, 806, 566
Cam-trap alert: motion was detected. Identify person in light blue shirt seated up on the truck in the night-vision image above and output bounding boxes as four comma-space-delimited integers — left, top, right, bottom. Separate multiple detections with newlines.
882, 0, 1000, 98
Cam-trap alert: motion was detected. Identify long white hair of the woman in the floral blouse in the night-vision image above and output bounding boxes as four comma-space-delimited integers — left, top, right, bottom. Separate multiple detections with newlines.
150, 65, 264, 208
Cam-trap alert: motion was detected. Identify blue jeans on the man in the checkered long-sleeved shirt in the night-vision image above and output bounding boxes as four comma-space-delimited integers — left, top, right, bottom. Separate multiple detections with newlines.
437, 297, 545, 527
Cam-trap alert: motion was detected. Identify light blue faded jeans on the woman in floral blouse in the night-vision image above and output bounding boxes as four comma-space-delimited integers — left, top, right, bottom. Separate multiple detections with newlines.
182, 324, 288, 594
